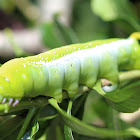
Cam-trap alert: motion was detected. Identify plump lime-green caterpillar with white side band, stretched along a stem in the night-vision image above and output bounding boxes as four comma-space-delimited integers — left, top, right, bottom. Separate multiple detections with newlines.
0, 33, 140, 106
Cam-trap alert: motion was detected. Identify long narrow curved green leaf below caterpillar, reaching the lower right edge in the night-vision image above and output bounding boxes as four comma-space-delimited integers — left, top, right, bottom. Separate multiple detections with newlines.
49, 98, 140, 138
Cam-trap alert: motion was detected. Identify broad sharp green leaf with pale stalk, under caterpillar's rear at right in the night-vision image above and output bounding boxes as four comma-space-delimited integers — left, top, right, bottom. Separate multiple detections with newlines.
94, 81, 140, 112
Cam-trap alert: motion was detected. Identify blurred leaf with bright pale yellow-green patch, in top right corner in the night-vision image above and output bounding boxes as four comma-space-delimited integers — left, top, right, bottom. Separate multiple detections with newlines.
91, 0, 140, 31
